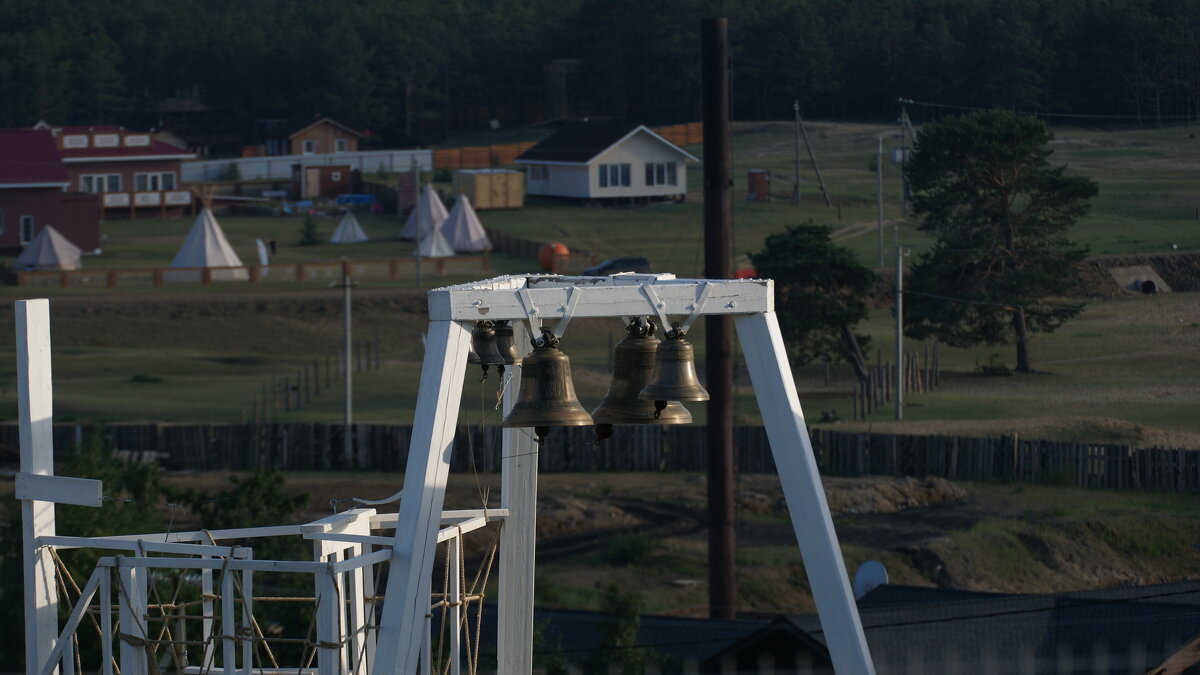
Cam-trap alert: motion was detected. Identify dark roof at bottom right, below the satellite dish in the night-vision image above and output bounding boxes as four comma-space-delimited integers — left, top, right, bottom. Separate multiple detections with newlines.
788, 581, 1200, 673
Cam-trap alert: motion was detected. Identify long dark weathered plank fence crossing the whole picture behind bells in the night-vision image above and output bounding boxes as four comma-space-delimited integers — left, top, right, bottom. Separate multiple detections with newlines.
16, 424, 1200, 492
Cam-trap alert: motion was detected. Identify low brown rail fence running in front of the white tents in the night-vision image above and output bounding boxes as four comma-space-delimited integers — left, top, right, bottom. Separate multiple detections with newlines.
13, 255, 488, 288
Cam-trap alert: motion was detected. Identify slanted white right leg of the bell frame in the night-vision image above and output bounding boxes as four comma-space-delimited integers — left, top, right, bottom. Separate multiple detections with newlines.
736, 311, 875, 675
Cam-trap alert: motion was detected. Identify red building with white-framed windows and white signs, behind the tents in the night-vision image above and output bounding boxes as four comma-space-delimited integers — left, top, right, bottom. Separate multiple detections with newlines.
40, 125, 196, 217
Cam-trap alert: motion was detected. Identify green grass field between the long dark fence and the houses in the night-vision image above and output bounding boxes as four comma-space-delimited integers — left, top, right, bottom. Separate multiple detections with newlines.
0, 123, 1200, 447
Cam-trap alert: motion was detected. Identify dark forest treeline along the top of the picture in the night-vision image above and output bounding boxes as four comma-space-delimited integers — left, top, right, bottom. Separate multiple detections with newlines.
0, 0, 1200, 141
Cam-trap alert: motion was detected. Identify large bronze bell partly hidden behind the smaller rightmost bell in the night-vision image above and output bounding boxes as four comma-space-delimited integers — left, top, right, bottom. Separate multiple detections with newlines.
592, 318, 691, 440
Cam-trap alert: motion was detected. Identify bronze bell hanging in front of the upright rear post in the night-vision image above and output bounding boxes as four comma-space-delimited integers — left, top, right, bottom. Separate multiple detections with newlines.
500, 330, 592, 442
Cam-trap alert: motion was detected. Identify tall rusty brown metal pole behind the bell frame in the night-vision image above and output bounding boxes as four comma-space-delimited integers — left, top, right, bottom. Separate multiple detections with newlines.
701, 18, 737, 619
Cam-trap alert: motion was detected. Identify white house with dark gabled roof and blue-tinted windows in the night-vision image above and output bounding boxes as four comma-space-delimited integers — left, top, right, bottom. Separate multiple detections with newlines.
516, 121, 698, 199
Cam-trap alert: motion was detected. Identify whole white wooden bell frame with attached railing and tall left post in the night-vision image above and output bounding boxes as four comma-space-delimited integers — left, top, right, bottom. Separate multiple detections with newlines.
17, 274, 874, 675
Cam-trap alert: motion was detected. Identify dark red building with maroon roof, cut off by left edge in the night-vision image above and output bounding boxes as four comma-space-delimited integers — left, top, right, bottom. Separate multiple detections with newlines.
0, 129, 100, 252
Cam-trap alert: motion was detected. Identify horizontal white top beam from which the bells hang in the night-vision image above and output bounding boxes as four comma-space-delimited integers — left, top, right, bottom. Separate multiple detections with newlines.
430, 276, 774, 321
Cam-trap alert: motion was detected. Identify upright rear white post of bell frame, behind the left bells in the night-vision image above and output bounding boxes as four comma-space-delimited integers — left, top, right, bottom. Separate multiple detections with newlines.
496, 321, 538, 675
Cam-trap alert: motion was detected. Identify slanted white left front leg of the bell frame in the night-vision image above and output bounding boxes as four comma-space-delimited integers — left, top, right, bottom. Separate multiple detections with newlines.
372, 321, 470, 675
